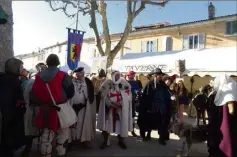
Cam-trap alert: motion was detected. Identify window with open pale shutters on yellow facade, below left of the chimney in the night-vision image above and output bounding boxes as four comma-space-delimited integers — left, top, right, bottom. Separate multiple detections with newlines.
183, 33, 205, 50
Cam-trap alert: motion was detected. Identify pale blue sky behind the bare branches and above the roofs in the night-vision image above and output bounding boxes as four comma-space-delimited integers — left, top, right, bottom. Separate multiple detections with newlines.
13, 1, 237, 55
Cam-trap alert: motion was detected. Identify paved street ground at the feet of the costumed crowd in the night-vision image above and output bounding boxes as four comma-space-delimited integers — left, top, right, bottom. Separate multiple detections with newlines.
20, 113, 208, 157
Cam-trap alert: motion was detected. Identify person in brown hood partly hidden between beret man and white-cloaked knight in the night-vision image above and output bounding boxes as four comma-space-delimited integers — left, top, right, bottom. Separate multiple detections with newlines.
91, 69, 106, 113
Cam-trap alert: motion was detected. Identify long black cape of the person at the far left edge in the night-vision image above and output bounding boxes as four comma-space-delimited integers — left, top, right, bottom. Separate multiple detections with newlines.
0, 73, 25, 150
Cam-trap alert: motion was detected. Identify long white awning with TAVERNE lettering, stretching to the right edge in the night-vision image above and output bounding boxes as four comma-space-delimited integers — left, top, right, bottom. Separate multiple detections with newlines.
112, 47, 237, 77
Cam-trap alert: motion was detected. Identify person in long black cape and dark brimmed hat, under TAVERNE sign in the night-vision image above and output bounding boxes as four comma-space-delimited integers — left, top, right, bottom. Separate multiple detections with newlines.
138, 69, 171, 145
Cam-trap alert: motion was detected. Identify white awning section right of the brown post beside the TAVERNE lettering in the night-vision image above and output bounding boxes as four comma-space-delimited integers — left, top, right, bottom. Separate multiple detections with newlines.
182, 47, 237, 77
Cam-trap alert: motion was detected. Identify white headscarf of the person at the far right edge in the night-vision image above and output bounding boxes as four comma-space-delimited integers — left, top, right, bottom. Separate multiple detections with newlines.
214, 75, 237, 106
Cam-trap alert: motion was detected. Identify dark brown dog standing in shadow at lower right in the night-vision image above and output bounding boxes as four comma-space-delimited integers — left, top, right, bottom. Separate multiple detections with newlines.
170, 120, 207, 156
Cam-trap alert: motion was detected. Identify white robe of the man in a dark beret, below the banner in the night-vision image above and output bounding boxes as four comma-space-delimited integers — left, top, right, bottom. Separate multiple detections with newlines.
70, 81, 96, 142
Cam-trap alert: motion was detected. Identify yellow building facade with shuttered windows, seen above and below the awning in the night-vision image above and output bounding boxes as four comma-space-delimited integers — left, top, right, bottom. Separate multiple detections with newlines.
111, 14, 237, 92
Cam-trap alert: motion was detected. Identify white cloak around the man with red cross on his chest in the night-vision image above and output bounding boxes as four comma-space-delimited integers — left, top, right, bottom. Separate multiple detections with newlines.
97, 79, 133, 137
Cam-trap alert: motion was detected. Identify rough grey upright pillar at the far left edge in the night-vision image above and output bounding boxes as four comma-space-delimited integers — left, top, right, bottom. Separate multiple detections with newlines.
0, 0, 14, 72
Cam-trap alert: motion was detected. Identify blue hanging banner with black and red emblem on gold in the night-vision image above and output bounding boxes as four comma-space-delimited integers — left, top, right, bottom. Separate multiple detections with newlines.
67, 28, 85, 70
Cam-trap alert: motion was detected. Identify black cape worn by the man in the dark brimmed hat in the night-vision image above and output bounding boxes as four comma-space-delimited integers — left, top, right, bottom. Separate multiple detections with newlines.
137, 80, 171, 131
